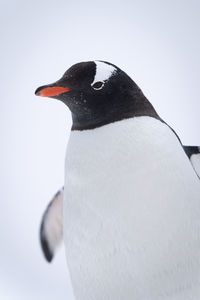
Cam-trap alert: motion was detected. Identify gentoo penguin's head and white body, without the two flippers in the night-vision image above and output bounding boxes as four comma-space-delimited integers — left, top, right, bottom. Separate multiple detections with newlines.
36, 61, 200, 300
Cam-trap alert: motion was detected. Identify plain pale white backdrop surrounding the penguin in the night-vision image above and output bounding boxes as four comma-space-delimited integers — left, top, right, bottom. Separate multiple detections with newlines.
0, 0, 200, 300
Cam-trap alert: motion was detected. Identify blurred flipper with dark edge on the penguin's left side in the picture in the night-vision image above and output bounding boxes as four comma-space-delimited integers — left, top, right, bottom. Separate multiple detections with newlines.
40, 188, 64, 262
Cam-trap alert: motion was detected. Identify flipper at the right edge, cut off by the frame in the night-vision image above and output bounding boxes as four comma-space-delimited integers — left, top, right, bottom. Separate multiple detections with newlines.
183, 146, 200, 178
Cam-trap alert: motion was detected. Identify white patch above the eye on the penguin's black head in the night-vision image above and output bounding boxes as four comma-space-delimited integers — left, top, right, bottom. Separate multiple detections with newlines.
91, 61, 117, 87
